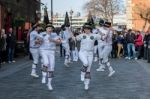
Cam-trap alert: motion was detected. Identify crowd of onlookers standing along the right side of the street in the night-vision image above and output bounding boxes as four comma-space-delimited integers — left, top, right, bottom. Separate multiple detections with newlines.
111, 29, 150, 59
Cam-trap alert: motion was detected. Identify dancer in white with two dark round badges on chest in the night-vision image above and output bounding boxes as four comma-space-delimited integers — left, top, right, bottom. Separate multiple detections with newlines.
76, 23, 101, 90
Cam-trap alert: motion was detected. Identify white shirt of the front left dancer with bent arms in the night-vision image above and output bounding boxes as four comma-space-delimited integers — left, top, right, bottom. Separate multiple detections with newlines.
40, 32, 59, 50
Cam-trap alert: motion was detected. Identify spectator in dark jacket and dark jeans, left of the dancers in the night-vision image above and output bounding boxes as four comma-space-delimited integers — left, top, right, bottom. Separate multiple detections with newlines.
6, 28, 16, 63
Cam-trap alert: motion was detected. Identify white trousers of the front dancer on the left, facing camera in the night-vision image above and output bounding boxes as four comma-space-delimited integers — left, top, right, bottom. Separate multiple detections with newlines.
40, 50, 55, 71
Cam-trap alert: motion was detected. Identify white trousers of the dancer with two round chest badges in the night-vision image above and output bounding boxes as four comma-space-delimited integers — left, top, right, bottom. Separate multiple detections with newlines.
79, 51, 93, 72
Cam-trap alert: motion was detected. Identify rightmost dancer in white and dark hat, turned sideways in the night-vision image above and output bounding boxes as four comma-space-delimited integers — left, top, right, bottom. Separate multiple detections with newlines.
97, 22, 115, 77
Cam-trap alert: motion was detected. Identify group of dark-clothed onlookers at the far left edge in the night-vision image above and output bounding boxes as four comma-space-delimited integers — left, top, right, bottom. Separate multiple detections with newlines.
0, 28, 16, 68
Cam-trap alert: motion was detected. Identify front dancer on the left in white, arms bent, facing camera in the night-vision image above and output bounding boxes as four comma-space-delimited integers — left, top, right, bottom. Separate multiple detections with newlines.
39, 24, 61, 90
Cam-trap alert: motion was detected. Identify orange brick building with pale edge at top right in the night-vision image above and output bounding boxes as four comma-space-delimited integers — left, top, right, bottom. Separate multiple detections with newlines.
126, 0, 150, 31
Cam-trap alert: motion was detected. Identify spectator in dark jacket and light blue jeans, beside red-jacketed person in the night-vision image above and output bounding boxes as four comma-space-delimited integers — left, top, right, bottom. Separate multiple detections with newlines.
126, 29, 137, 60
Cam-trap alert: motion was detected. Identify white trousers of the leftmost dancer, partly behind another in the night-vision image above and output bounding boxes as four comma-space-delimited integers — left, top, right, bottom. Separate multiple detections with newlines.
30, 48, 40, 64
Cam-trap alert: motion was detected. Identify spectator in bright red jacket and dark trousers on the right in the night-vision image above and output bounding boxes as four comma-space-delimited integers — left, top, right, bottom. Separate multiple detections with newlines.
135, 31, 144, 59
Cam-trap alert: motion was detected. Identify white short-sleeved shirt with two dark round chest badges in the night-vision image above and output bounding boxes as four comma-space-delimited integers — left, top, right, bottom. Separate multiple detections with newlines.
76, 33, 101, 51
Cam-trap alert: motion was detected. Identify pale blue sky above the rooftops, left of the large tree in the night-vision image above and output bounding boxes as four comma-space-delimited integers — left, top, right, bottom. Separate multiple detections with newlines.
41, 0, 88, 14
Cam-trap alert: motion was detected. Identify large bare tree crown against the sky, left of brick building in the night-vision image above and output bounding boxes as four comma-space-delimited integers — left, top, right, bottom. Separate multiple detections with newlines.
84, 0, 120, 23
